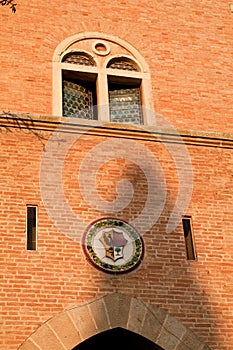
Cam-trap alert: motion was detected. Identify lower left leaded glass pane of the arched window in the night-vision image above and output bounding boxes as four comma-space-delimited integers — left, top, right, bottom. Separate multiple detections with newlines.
63, 80, 95, 119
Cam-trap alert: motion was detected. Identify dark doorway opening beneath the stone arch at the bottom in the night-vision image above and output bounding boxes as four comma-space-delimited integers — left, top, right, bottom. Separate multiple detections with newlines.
72, 327, 164, 350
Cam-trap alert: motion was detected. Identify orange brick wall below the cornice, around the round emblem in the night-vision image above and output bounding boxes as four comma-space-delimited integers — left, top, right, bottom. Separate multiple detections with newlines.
0, 122, 233, 350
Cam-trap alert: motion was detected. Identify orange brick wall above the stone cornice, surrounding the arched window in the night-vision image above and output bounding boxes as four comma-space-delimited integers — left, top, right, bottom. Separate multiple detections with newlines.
0, 0, 233, 131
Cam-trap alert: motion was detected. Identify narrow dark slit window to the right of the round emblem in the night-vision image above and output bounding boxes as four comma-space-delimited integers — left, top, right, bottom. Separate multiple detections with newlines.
182, 216, 197, 260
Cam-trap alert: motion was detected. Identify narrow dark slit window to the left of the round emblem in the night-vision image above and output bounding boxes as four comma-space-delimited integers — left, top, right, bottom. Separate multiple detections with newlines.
27, 205, 37, 250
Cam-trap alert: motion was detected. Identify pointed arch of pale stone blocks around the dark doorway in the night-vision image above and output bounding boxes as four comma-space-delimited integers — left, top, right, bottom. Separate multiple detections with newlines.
18, 293, 210, 350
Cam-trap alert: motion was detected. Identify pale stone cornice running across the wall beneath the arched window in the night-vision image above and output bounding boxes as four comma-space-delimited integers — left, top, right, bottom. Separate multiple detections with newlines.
0, 112, 233, 149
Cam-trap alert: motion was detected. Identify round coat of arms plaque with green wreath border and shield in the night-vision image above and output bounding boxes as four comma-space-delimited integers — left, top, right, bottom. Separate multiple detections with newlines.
82, 218, 144, 273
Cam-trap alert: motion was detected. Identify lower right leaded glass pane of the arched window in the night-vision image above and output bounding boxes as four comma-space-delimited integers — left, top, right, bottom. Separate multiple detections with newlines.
109, 88, 142, 124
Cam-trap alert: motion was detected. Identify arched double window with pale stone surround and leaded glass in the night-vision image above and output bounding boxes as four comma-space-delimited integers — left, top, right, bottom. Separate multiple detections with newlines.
53, 33, 153, 125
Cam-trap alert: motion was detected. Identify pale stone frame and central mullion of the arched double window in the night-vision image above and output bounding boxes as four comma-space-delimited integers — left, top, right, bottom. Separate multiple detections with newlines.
52, 32, 155, 126
